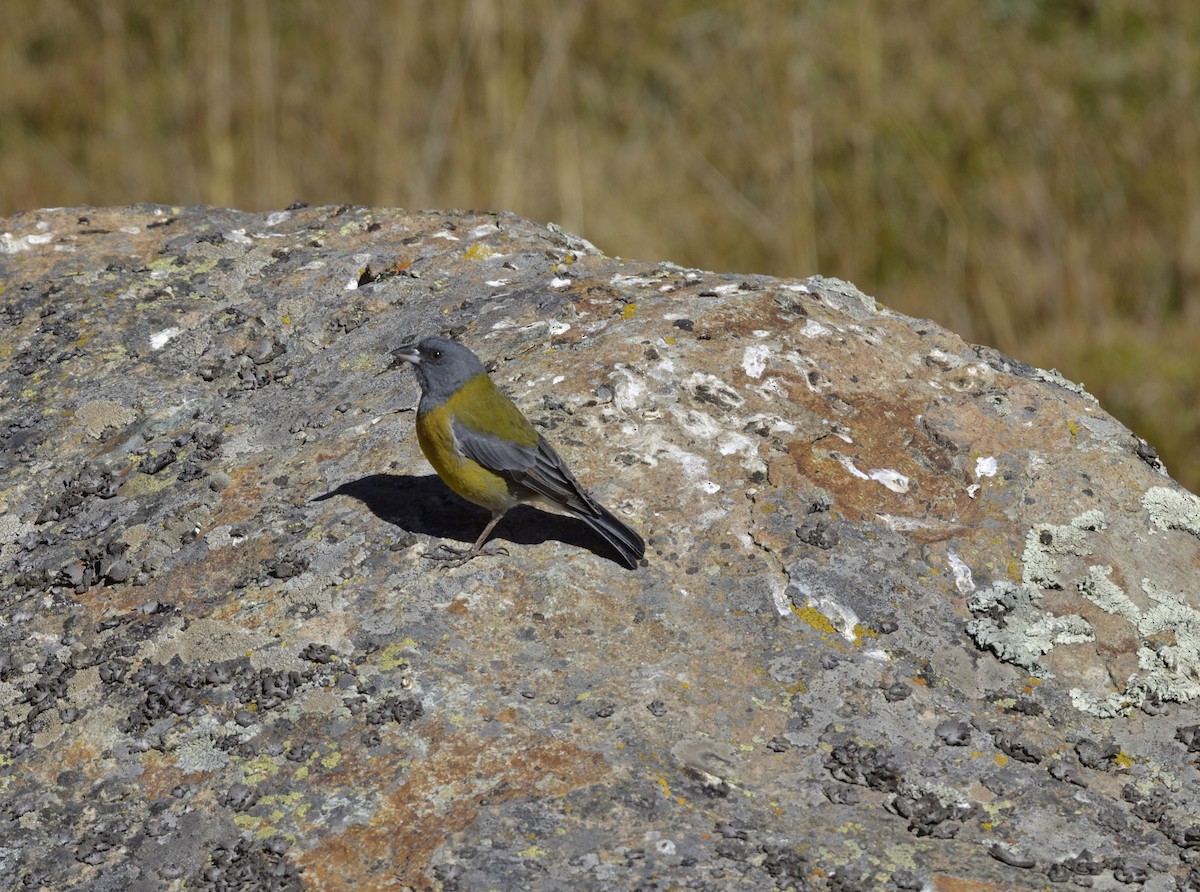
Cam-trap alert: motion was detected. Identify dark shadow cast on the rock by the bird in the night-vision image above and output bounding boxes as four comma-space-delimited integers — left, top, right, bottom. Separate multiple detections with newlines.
311, 474, 620, 563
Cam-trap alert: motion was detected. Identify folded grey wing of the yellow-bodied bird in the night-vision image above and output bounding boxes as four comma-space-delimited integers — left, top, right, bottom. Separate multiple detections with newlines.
450, 419, 598, 514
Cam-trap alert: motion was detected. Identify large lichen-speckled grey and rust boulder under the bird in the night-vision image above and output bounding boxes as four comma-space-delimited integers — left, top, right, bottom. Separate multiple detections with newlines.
0, 206, 1200, 891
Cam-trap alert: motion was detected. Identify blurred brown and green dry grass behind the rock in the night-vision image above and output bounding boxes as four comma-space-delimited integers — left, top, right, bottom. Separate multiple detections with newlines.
0, 0, 1200, 490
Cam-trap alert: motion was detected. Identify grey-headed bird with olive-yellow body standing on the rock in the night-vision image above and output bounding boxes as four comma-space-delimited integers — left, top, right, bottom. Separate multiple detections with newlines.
385, 336, 646, 569
